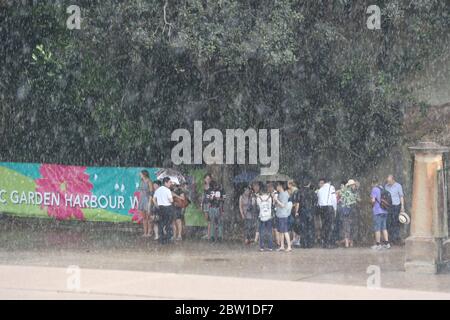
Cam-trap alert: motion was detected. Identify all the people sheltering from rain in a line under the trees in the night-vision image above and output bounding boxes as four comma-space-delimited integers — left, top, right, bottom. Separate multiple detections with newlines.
138, 170, 405, 252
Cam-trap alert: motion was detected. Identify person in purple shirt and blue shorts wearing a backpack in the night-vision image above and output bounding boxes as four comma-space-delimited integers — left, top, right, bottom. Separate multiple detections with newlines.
370, 177, 391, 250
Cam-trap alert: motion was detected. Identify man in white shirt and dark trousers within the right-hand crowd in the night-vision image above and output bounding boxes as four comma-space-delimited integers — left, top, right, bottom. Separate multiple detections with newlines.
317, 178, 337, 249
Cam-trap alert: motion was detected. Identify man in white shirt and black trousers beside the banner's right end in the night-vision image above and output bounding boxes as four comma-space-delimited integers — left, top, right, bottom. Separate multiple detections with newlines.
153, 177, 174, 244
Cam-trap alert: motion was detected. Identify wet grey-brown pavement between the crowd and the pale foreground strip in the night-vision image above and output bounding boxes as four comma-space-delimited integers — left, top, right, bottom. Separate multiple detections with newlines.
0, 216, 450, 293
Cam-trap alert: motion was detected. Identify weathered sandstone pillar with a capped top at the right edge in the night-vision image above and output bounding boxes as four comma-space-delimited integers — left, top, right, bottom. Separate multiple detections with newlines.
405, 142, 449, 273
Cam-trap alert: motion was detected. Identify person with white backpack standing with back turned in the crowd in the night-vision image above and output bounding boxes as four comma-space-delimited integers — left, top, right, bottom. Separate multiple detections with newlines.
256, 187, 273, 251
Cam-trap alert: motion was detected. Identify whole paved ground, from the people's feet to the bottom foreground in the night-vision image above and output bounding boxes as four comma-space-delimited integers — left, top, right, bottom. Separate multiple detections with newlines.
0, 219, 450, 298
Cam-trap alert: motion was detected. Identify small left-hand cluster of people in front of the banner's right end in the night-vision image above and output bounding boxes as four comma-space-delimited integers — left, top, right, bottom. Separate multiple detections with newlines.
138, 170, 189, 244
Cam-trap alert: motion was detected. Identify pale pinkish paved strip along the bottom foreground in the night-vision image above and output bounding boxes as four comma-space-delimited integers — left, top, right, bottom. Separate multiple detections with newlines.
0, 266, 450, 300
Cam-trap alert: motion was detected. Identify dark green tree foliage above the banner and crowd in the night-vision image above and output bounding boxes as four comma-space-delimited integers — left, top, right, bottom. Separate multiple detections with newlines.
0, 0, 450, 176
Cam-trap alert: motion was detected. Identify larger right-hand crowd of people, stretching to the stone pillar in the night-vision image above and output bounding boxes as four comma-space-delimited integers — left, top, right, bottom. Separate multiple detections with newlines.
239, 175, 405, 252
